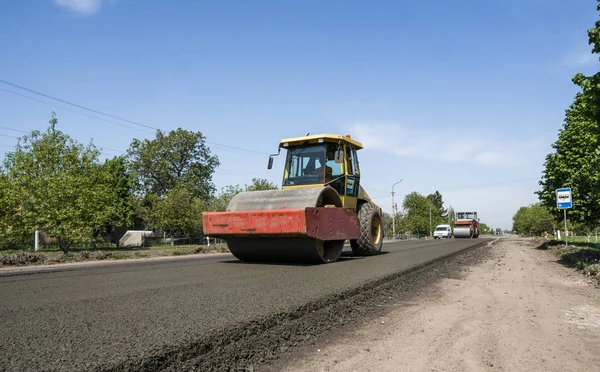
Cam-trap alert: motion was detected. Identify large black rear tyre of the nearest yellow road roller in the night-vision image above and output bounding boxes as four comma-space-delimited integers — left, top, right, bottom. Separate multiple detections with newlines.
350, 203, 383, 256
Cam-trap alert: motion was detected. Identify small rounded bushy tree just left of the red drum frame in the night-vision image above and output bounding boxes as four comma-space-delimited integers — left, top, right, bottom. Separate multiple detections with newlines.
147, 186, 204, 237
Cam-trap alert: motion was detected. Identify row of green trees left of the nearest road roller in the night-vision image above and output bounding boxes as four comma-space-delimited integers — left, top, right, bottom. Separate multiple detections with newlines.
0, 113, 277, 253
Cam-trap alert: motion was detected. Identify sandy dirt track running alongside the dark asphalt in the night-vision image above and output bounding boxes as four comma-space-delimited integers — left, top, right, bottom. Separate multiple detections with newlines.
273, 237, 600, 372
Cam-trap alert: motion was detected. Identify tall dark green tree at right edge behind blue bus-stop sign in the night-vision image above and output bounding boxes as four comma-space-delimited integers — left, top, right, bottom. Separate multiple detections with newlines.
536, 0, 600, 230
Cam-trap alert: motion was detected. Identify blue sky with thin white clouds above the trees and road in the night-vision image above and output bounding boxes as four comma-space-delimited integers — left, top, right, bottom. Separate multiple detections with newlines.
0, 0, 598, 228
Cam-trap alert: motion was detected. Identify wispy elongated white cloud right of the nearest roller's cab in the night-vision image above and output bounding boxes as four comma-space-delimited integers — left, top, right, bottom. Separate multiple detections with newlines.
350, 123, 541, 166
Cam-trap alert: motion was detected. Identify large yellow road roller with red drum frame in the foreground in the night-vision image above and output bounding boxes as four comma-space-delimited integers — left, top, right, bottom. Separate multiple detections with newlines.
202, 134, 385, 264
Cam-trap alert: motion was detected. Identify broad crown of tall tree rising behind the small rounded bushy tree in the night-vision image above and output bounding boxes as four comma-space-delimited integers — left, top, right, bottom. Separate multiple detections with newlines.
128, 128, 219, 202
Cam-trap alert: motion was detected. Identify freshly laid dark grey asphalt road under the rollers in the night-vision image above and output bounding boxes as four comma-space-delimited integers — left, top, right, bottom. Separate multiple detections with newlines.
0, 238, 487, 371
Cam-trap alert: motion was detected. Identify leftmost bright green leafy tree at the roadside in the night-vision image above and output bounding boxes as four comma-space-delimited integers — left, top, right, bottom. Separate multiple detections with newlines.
2, 113, 113, 254
